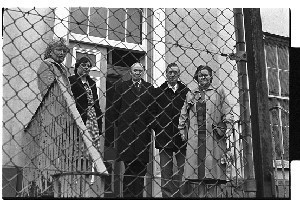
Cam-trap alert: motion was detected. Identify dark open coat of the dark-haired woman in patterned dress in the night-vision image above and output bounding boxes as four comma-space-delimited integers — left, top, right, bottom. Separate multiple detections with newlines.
69, 74, 102, 129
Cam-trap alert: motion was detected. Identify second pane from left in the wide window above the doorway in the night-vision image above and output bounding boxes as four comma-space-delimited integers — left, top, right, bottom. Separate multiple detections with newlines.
89, 8, 107, 38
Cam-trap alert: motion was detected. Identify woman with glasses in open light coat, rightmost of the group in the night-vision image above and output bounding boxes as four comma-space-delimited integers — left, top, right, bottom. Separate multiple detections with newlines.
178, 65, 233, 196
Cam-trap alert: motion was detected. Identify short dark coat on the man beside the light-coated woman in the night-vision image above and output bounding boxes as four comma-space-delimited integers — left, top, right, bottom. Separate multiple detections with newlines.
155, 81, 189, 151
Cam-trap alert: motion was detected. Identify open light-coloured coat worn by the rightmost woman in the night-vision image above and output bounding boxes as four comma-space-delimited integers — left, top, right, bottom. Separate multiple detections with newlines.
178, 86, 232, 180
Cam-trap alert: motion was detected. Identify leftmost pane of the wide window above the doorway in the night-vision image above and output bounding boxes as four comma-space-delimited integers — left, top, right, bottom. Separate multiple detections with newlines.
70, 7, 89, 35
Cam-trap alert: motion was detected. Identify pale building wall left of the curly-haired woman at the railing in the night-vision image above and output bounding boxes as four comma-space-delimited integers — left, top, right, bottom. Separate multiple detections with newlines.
2, 8, 54, 166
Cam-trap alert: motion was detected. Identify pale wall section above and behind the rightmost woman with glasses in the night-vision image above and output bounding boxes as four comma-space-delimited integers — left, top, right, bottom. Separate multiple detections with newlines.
165, 8, 239, 116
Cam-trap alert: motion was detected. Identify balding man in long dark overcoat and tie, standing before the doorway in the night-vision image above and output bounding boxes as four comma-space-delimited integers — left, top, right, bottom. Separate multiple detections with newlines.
113, 63, 154, 197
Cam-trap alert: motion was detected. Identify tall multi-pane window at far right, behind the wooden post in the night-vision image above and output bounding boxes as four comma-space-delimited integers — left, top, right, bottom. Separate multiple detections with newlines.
264, 33, 290, 160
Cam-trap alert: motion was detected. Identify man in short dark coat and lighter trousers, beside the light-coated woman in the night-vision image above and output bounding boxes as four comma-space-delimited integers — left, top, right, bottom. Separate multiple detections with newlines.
155, 63, 188, 198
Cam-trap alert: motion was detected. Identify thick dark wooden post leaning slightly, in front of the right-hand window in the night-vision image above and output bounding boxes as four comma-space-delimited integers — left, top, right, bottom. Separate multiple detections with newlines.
244, 8, 274, 198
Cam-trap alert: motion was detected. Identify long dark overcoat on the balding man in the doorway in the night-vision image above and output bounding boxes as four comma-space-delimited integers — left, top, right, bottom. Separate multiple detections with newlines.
112, 80, 154, 162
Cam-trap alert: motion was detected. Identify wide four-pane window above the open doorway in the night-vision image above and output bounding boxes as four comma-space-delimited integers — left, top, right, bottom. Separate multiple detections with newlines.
69, 7, 143, 44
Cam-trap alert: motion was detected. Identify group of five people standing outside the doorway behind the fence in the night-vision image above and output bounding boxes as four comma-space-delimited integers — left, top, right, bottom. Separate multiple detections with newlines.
38, 40, 233, 198
